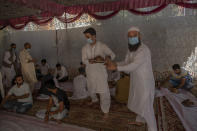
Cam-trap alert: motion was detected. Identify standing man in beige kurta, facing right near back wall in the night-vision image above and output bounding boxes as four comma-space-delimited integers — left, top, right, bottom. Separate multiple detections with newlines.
19, 43, 37, 92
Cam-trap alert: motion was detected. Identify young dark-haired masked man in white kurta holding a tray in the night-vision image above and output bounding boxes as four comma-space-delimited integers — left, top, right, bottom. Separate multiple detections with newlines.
82, 28, 115, 118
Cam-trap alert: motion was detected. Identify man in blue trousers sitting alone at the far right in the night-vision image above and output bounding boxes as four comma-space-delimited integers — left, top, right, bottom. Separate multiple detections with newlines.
169, 64, 194, 90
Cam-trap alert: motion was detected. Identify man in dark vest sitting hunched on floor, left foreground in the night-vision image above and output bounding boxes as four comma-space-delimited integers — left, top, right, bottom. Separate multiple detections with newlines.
36, 79, 70, 122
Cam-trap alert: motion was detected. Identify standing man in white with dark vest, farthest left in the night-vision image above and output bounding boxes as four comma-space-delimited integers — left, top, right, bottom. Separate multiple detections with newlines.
2, 43, 16, 87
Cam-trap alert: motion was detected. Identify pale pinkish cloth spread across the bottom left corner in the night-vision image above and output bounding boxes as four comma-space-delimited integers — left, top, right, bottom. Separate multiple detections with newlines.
0, 111, 93, 131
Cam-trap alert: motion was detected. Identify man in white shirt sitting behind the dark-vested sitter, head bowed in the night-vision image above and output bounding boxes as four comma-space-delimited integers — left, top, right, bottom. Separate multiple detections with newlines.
54, 64, 68, 82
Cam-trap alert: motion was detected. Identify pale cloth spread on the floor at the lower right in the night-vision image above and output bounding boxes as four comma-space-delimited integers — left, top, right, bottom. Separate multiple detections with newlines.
157, 88, 197, 131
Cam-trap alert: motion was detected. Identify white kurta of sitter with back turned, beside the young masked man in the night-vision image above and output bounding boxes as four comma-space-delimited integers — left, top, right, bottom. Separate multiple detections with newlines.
70, 75, 88, 99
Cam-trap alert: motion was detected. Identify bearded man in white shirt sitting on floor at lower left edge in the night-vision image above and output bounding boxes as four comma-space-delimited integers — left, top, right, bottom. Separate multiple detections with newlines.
0, 75, 33, 113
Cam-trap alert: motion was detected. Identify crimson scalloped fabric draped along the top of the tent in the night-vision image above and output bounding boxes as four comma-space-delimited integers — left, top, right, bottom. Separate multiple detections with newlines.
0, 0, 197, 29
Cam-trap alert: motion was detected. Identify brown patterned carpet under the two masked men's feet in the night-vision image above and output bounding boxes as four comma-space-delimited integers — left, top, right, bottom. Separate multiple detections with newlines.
24, 94, 184, 131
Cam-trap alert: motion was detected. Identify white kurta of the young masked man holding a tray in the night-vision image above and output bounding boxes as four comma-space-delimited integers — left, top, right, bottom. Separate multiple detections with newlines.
82, 42, 115, 94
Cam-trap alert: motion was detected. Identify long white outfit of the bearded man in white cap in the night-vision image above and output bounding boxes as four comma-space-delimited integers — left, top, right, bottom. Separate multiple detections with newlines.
118, 44, 157, 131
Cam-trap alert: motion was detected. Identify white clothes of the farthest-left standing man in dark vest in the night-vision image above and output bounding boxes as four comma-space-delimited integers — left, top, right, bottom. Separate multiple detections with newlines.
2, 51, 16, 87
